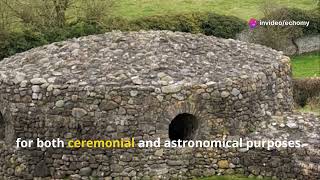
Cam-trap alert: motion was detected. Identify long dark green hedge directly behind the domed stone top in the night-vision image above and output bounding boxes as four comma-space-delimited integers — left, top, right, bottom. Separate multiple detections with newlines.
0, 13, 246, 59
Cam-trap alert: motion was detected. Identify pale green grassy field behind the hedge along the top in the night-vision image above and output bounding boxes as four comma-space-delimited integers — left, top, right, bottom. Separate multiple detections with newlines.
113, 0, 316, 20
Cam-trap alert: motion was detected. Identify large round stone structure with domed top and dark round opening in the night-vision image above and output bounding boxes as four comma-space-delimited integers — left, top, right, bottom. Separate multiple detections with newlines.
0, 31, 319, 179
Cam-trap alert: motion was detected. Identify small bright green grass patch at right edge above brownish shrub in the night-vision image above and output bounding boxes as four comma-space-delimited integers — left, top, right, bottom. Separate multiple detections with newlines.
291, 53, 320, 78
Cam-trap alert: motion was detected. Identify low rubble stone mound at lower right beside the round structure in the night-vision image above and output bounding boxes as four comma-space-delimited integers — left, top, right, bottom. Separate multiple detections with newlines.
239, 113, 320, 180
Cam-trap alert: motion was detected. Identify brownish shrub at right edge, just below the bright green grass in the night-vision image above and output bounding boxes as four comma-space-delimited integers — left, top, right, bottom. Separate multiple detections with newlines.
293, 78, 320, 107
